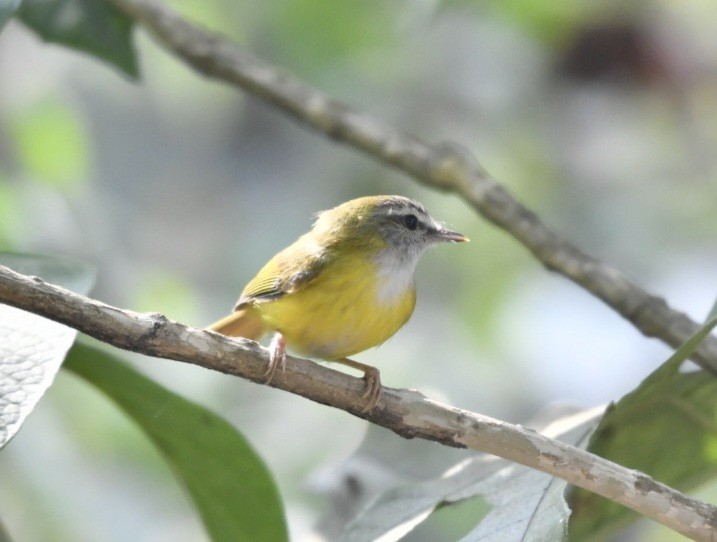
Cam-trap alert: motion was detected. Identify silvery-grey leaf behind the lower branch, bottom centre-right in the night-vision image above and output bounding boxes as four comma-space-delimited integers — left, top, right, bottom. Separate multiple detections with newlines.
341, 412, 597, 542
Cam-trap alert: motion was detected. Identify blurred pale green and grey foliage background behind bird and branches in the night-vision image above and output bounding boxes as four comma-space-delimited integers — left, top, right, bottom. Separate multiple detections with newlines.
0, 0, 717, 542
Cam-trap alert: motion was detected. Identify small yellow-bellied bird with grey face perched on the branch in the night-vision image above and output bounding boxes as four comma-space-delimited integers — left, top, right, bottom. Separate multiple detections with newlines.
207, 195, 469, 413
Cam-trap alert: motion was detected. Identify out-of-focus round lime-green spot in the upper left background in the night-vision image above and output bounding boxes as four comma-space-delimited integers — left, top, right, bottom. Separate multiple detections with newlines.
12, 99, 89, 188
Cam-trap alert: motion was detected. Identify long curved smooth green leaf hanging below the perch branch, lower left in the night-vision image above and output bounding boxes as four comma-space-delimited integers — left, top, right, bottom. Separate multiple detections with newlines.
65, 344, 288, 542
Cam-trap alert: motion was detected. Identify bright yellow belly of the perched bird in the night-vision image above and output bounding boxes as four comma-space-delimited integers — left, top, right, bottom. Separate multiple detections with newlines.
256, 259, 416, 360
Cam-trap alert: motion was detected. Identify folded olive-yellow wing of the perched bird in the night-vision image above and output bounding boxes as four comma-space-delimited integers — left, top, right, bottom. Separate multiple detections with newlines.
234, 242, 326, 310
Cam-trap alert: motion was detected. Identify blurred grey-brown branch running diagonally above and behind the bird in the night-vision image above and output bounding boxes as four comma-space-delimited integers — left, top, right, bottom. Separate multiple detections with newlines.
105, 0, 717, 373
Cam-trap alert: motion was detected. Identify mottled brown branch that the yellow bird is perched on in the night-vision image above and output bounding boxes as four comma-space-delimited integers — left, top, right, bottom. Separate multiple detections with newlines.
0, 266, 717, 542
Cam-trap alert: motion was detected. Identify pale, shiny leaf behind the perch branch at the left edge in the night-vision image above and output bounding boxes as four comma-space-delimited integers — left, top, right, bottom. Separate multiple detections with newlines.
0, 253, 95, 448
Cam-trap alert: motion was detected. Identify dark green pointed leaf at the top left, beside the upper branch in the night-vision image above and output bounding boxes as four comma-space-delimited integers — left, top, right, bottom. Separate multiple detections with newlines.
18, 0, 139, 79
